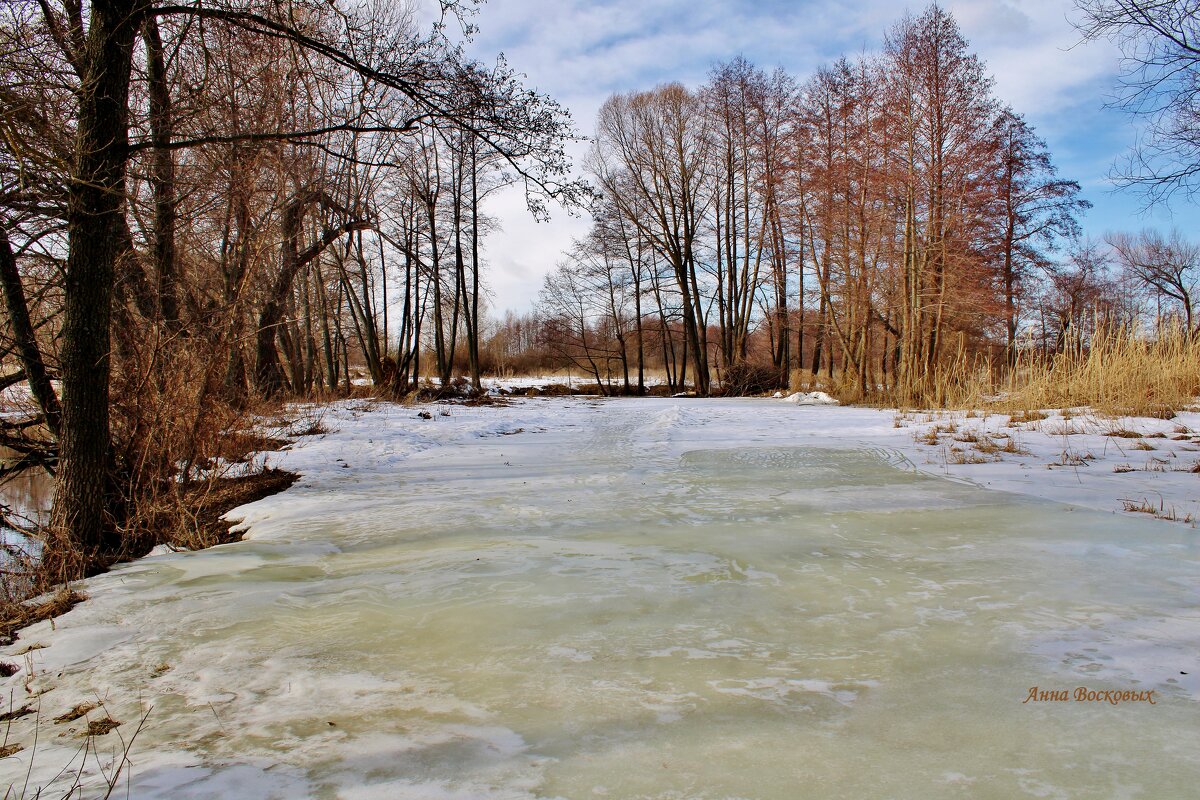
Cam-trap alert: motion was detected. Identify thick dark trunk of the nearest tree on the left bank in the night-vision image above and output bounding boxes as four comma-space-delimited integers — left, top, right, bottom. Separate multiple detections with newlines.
46, 0, 140, 579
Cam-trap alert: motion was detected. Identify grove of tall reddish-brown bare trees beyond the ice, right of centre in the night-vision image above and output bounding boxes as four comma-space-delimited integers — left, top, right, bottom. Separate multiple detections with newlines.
532, 5, 1200, 405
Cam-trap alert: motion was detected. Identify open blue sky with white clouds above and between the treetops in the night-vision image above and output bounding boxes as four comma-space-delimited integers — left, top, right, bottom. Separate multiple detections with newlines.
446, 0, 1200, 314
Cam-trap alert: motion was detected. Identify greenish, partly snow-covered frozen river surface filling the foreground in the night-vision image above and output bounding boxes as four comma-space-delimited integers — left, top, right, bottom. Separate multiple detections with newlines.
0, 399, 1200, 800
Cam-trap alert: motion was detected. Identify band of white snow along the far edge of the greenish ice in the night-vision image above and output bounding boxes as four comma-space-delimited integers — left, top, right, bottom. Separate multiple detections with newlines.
241, 398, 1200, 525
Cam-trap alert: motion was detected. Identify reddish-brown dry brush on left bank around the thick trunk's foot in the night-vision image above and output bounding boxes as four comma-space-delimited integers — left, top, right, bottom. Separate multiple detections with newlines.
0, 325, 295, 614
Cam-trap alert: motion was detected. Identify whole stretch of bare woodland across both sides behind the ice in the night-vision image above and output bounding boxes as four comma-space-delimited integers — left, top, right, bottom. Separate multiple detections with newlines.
0, 0, 1200, 587
